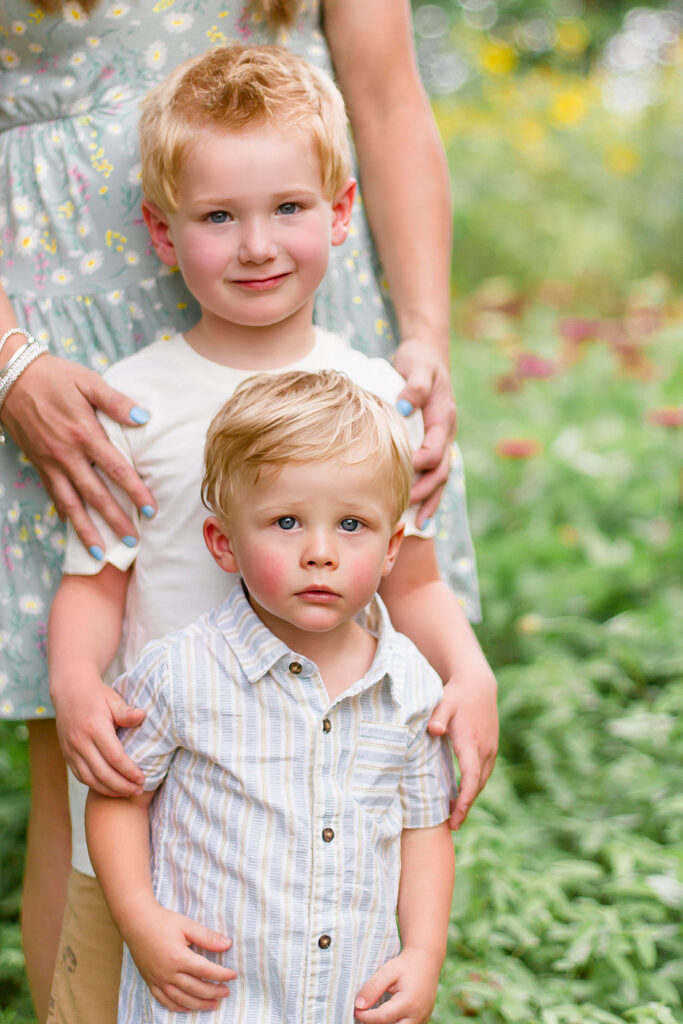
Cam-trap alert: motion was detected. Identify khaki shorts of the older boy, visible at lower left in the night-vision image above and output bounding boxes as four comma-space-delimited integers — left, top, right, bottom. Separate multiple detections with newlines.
47, 868, 123, 1024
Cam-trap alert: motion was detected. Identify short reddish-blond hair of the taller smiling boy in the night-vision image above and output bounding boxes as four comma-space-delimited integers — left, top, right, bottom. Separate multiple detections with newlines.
140, 43, 351, 212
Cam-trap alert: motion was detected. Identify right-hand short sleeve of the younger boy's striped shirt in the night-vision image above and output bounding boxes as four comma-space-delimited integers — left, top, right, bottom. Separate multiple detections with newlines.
399, 719, 458, 828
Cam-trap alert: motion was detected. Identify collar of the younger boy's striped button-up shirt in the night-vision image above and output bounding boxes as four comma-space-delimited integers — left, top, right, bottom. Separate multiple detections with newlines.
213, 581, 405, 703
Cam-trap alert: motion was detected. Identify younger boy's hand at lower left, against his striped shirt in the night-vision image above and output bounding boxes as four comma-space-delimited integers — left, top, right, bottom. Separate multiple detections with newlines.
122, 902, 237, 1012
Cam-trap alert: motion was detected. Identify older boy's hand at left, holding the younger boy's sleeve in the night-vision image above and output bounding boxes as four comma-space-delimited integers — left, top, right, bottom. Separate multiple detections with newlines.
52, 673, 144, 797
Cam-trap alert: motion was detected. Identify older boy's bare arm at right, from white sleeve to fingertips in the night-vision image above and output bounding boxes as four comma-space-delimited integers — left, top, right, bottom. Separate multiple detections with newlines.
380, 537, 498, 828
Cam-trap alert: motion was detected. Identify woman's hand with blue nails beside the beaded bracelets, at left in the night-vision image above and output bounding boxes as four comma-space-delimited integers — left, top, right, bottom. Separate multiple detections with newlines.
2, 355, 155, 548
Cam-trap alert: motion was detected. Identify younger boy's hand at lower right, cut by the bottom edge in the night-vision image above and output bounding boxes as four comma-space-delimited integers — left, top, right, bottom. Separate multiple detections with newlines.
354, 947, 441, 1024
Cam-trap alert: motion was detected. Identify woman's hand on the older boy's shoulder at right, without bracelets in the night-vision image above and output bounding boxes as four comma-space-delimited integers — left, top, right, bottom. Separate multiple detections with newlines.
393, 338, 457, 524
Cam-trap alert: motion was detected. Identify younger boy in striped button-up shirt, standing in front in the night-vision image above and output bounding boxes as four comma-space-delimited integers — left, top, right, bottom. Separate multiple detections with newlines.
87, 371, 455, 1024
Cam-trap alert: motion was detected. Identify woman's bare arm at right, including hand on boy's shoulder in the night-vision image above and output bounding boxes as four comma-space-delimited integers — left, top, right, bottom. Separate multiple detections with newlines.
323, 0, 456, 517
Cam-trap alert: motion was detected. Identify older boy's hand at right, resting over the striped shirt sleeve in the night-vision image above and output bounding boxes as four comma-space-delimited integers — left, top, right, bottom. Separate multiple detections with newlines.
428, 656, 498, 828
